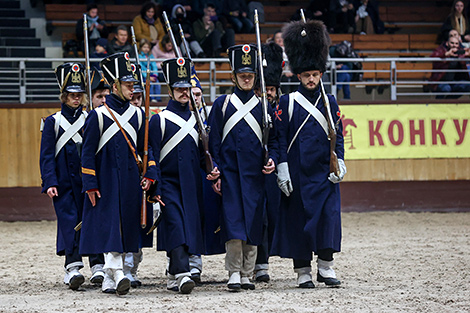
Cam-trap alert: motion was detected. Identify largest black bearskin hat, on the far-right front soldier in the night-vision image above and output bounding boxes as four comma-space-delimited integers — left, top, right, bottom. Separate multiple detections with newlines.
282, 20, 330, 74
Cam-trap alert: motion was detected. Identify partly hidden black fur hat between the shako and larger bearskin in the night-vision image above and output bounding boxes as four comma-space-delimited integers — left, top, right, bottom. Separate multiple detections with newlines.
261, 42, 283, 87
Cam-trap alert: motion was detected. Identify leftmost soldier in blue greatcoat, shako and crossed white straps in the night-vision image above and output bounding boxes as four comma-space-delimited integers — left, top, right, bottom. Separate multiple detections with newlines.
40, 63, 104, 290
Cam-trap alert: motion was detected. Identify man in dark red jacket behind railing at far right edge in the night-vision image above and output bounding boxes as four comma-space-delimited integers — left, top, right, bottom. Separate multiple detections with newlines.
431, 37, 470, 99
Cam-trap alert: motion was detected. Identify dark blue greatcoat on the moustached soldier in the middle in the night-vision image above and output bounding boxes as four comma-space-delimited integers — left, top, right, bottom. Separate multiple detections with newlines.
149, 100, 204, 254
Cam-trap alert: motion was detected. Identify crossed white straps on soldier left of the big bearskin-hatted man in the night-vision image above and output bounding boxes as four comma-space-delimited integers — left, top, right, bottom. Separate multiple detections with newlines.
222, 94, 262, 143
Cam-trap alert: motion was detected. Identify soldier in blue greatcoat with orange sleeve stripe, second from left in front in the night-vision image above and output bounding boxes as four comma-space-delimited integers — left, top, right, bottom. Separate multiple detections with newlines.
80, 52, 157, 295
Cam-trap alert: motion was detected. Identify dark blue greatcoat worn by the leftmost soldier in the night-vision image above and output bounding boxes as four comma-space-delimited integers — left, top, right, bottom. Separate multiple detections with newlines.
40, 103, 84, 255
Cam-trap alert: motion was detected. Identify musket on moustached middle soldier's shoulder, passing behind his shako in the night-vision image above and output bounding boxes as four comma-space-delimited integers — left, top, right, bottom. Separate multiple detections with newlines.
163, 11, 214, 174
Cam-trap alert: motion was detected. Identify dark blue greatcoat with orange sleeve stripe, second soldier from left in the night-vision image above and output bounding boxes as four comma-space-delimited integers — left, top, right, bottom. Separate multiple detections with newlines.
80, 94, 157, 254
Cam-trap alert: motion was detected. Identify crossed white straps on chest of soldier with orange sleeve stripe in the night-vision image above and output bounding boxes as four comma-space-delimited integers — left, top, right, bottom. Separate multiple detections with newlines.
95, 105, 137, 154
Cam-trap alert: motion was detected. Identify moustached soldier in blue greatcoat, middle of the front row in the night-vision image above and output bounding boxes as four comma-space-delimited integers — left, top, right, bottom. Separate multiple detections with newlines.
149, 57, 218, 294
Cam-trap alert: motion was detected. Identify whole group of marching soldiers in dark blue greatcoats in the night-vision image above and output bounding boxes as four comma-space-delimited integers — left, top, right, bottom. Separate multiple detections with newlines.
40, 17, 346, 295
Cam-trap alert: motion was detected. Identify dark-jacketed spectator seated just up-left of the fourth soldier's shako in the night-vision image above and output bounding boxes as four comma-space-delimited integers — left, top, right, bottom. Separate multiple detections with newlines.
193, 3, 235, 58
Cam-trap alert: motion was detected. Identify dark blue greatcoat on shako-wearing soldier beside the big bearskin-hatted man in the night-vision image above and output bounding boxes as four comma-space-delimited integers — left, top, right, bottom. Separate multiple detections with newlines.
209, 88, 277, 245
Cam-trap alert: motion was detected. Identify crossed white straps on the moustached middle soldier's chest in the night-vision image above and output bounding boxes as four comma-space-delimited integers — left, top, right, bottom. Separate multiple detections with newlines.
158, 110, 199, 162
